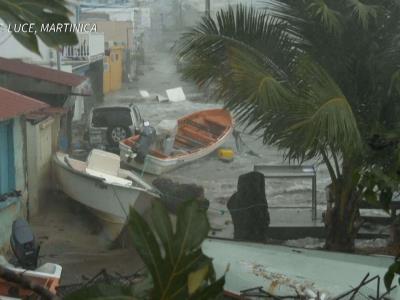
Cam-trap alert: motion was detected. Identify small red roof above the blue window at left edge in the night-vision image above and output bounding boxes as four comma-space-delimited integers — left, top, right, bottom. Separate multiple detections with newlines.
0, 87, 49, 121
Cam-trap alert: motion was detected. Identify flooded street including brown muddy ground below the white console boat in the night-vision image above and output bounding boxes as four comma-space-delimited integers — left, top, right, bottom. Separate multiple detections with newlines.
22, 2, 387, 285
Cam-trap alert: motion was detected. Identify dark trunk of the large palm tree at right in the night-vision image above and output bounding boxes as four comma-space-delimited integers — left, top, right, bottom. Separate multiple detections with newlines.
325, 158, 361, 252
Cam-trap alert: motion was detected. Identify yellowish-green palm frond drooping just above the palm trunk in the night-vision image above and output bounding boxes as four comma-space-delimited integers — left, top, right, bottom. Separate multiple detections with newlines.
271, 58, 361, 160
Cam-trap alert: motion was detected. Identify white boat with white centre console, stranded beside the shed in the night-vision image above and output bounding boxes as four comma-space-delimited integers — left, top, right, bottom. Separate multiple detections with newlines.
53, 149, 158, 235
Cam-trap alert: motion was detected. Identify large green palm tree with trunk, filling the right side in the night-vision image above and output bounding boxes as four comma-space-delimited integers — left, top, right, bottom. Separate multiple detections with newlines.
178, 0, 400, 251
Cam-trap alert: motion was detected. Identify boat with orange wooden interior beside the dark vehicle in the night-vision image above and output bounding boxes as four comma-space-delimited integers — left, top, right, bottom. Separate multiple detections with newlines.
119, 109, 233, 175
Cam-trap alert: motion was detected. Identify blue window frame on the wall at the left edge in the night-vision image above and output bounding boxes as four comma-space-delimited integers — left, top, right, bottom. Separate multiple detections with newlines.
0, 121, 15, 194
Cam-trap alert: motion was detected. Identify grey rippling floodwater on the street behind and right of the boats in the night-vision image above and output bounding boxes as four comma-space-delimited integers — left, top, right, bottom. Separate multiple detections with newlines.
101, 3, 330, 237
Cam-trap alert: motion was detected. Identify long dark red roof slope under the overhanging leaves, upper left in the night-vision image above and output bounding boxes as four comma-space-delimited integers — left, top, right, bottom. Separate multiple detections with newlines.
0, 57, 87, 87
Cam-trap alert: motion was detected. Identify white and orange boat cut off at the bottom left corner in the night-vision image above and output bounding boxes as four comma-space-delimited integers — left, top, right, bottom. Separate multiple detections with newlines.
0, 255, 62, 299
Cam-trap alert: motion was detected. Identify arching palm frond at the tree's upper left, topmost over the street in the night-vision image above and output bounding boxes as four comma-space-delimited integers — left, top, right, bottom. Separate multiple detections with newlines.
178, 5, 295, 84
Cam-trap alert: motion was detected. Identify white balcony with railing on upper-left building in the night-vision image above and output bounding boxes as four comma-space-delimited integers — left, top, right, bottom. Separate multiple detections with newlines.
61, 32, 104, 64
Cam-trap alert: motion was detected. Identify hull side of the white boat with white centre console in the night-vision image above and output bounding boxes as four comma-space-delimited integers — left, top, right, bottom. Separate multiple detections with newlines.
53, 153, 151, 231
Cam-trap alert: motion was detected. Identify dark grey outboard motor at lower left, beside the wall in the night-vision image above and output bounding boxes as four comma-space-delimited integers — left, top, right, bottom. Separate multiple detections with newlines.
10, 219, 40, 270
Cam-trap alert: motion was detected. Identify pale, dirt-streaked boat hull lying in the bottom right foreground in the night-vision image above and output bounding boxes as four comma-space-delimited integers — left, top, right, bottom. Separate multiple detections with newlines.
202, 239, 400, 300
